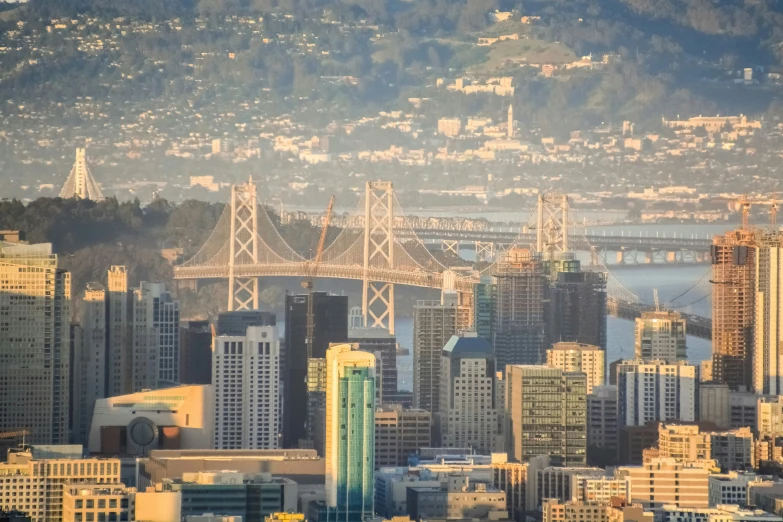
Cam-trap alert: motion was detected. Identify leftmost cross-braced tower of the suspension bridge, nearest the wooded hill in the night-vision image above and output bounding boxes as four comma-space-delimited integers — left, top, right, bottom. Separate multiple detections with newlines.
228, 179, 258, 312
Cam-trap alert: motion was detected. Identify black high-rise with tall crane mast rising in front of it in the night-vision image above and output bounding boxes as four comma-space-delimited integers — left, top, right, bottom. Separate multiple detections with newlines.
283, 292, 348, 448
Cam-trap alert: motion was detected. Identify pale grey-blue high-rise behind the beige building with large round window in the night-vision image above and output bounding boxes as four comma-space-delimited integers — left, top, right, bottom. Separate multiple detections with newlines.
132, 281, 179, 392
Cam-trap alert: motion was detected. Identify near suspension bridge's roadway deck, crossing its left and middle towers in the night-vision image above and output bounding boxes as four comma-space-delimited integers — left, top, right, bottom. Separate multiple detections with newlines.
174, 263, 479, 294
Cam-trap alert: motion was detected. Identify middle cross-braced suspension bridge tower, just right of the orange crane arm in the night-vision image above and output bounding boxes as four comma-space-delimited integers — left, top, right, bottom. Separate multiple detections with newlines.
362, 181, 394, 335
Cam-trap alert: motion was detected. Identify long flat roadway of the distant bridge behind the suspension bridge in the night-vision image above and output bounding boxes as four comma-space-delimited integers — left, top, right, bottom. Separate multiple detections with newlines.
402, 229, 712, 252
